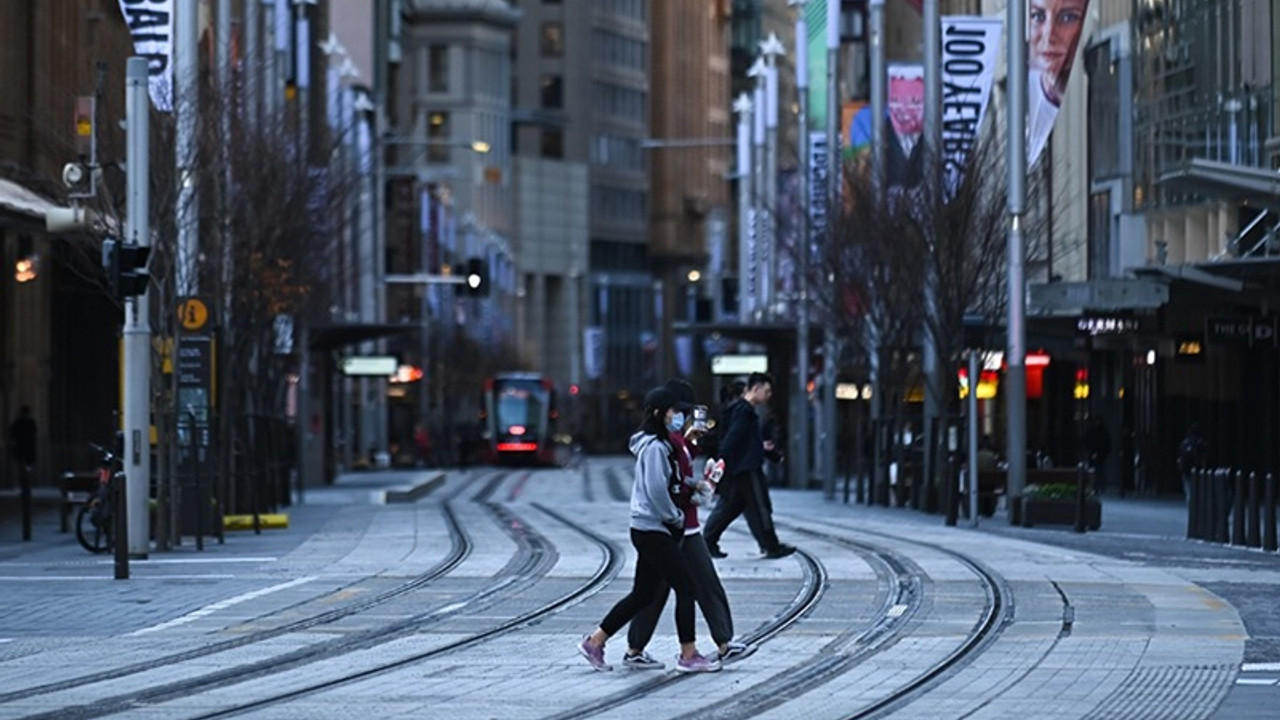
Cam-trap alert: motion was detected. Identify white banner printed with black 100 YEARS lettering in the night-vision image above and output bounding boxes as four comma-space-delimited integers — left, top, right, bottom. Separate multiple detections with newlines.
942, 15, 1004, 191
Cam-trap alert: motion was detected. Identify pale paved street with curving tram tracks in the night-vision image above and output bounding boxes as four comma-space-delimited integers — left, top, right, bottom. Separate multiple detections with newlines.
0, 456, 1280, 720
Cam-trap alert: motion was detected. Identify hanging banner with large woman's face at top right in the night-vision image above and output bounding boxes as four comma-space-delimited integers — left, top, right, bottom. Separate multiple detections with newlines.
1027, 0, 1089, 168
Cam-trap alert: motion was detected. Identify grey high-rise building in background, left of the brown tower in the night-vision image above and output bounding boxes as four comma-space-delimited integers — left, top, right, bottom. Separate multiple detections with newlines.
513, 0, 658, 437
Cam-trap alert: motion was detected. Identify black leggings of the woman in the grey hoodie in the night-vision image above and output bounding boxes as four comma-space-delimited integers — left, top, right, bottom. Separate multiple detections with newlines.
600, 528, 696, 644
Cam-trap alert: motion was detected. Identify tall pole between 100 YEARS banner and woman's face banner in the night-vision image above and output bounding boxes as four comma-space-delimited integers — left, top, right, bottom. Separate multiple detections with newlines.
1005, 1, 1027, 525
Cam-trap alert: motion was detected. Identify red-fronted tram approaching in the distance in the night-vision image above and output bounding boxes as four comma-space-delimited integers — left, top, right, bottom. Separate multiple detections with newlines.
483, 373, 559, 465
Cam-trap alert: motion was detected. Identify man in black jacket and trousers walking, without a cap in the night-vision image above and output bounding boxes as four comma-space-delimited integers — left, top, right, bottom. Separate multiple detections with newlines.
703, 373, 796, 559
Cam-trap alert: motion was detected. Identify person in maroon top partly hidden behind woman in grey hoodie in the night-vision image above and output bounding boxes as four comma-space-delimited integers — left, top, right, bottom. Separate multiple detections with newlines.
622, 378, 755, 670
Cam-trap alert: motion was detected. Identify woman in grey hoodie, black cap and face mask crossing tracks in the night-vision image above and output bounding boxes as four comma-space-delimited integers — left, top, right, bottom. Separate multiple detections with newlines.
577, 387, 721, 673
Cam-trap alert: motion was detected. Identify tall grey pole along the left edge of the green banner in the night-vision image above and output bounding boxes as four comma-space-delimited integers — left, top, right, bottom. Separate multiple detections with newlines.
787, 0, 809, 487
